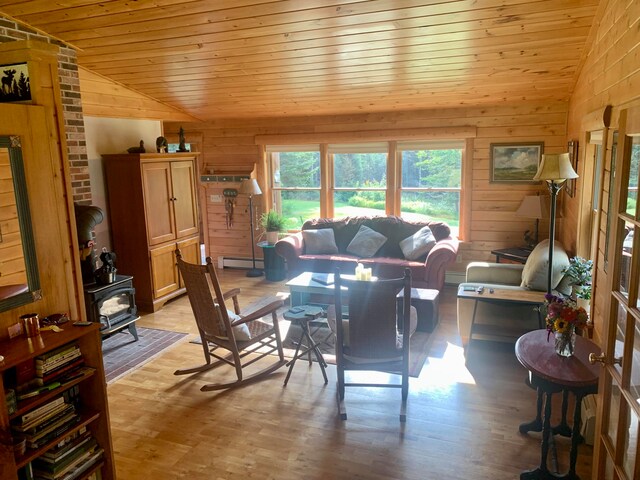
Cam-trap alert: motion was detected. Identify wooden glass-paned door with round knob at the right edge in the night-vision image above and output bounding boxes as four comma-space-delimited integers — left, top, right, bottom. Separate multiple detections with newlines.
593, 107, 640, 480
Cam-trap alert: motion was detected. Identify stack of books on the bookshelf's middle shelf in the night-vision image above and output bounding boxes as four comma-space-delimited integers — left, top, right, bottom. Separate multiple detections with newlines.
11, 396, 80, 448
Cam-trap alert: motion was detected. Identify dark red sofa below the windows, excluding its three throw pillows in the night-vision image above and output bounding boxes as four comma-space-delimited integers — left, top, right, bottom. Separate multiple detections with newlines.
275, 216, 459, 290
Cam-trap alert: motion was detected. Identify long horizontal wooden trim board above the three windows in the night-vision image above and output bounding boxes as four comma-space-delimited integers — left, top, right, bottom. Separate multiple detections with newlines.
254, 126, 477, 145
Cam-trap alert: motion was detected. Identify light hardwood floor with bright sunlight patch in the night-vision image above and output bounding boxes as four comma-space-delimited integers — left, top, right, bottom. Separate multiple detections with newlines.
108, 270, 592, 480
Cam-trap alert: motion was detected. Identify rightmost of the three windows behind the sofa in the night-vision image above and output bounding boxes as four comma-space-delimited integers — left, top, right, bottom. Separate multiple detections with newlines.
398, 142, 464, 235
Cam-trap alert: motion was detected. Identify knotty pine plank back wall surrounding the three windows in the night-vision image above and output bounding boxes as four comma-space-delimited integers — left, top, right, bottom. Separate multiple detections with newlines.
165, 102, 568, 271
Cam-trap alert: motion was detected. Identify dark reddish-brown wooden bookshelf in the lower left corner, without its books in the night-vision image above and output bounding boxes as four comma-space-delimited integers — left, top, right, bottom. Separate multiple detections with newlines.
0, 323, 115, 480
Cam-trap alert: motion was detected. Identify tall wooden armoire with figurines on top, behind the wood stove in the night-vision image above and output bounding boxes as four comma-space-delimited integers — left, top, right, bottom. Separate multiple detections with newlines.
102, 152, 200, 312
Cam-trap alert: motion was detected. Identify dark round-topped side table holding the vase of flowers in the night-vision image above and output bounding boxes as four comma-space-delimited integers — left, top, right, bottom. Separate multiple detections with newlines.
516, 330, 600, 480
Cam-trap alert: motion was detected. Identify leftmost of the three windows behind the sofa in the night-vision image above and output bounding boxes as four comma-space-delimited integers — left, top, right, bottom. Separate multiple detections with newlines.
267, 145, 320, 229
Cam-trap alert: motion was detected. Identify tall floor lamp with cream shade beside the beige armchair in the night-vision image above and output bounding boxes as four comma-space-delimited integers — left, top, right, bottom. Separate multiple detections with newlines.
533, 153, 578, 295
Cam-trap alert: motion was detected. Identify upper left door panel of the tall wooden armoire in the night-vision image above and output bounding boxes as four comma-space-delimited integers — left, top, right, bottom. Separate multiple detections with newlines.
142, 162, 176, 245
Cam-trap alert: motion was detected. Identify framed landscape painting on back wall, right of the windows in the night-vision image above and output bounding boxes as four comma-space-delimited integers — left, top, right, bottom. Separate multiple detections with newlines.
489, 142, 544, 183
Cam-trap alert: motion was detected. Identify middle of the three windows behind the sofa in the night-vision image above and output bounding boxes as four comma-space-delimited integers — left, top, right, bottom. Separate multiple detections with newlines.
329, 143, 388, 217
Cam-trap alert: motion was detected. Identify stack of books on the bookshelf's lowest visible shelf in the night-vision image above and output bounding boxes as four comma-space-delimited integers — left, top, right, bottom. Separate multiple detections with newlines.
33, 428, 104, 480
